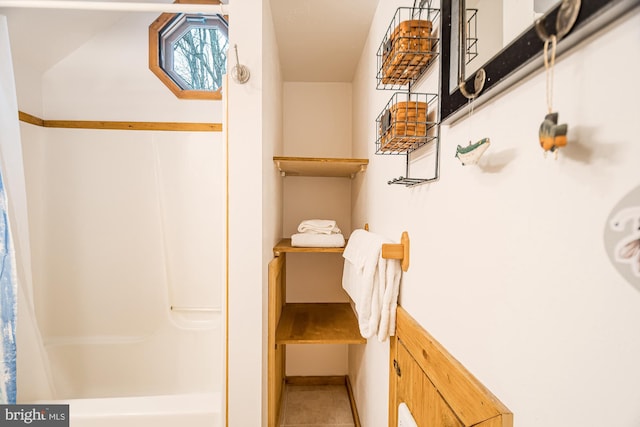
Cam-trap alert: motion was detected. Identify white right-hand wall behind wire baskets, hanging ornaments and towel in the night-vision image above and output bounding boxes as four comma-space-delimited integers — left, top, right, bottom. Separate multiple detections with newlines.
350, 4, 640, 427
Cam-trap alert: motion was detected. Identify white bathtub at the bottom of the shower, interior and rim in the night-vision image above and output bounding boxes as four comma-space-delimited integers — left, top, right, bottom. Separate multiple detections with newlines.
38, 310, 223, 427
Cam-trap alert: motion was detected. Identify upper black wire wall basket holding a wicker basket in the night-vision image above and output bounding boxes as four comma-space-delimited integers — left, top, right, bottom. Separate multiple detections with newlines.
376, 7, 440, 90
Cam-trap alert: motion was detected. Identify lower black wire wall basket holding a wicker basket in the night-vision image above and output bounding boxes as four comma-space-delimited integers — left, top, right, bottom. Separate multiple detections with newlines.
376, 92, 438, 154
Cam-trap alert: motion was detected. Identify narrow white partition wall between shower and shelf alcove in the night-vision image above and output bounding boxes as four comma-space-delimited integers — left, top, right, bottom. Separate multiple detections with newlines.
227, 0, 282, 426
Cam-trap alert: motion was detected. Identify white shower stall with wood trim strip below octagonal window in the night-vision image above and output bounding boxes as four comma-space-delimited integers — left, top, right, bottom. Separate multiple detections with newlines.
0, 5, 226, 427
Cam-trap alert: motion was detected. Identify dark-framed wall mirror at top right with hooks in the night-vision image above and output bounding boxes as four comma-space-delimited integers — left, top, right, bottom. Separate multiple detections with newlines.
440, 0, 640, 124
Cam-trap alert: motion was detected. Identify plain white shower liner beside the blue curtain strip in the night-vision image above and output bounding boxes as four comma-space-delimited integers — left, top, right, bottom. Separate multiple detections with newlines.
0, 15, 53, 402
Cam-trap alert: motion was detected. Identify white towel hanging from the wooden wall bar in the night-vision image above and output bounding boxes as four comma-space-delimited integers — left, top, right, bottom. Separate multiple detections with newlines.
342, 230, 401, 341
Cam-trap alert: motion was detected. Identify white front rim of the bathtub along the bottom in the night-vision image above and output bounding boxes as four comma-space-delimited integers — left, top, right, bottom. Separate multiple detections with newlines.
44, 393, 222, 427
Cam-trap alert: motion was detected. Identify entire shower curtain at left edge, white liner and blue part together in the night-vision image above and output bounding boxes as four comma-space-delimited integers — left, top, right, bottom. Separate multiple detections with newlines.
0, 15, 54, 403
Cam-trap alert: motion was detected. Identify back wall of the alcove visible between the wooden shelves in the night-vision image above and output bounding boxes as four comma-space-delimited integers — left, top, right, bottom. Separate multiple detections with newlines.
283, 82, 352, 376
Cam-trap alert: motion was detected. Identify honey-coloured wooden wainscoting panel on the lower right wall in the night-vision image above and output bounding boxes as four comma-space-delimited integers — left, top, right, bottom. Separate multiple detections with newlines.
389, 307, 513, 427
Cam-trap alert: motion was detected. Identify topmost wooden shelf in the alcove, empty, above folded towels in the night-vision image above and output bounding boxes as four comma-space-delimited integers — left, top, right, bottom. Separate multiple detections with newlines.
273, 156, 369, 178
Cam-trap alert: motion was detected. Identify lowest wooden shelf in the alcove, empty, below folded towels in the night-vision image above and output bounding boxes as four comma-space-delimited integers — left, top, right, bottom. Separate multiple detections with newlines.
276, 303, 367, 344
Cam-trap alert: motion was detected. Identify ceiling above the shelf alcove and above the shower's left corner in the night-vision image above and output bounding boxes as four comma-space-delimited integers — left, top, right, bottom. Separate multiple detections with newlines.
0, 0, 379, 82
